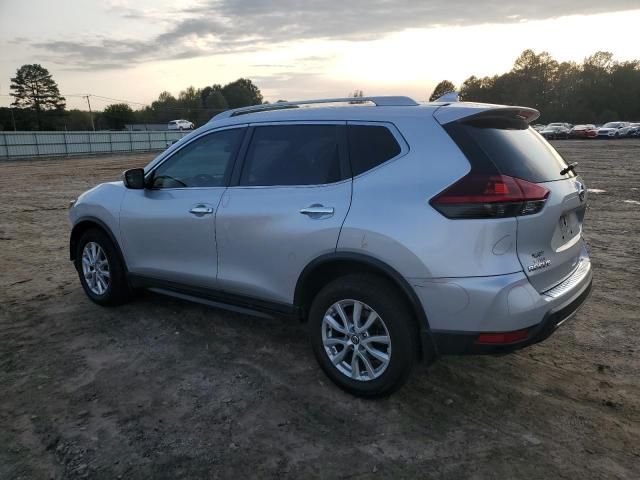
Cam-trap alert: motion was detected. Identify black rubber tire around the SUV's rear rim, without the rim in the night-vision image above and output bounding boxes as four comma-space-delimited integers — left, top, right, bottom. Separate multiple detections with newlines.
307, 274, 418, 397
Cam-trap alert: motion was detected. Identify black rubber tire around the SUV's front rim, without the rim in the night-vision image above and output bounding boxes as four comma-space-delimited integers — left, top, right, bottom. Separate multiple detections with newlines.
75, 228, 131, 306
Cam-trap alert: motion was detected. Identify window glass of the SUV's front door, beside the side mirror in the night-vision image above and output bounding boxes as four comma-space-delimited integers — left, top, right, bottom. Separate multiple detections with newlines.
153, 129, 243, 188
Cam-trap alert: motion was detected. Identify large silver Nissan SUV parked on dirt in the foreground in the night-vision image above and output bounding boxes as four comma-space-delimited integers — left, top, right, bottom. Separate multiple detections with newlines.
70, 97, 592, 396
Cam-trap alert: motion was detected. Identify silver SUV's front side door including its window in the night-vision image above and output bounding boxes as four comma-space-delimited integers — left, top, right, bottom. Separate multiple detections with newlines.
120, 128, 246, 287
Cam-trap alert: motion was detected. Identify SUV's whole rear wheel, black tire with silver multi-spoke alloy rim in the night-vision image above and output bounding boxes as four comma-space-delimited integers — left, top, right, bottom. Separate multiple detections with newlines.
308, 274, 417, 397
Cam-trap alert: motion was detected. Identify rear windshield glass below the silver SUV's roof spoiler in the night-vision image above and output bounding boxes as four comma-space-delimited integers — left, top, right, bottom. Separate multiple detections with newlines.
445, 122, 574, 183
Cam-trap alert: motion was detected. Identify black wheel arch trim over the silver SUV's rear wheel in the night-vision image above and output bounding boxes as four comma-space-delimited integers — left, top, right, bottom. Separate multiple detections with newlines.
293, 252, 438, 361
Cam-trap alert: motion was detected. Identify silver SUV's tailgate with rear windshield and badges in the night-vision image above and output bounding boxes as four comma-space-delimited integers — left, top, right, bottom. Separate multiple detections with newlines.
445, 109, 586, 292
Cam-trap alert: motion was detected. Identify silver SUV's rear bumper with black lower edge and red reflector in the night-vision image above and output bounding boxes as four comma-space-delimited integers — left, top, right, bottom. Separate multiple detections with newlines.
413, 250, 593, 354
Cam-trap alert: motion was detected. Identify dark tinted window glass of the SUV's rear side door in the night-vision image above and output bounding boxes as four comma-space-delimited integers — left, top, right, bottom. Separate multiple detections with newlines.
240, 125, 342, 186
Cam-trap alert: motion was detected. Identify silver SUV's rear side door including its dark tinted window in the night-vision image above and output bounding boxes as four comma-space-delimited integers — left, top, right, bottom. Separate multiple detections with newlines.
216, 122, 352, 304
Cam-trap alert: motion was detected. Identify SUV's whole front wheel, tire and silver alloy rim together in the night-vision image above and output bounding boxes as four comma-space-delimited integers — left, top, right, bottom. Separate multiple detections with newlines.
75, 229, 130, 305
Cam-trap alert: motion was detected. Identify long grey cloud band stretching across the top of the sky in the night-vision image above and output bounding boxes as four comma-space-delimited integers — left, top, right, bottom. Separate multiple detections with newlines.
22, 0, 638, 70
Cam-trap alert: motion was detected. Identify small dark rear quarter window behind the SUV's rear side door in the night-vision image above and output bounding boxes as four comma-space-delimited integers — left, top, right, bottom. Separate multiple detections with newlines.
348, 125, 401, 176
